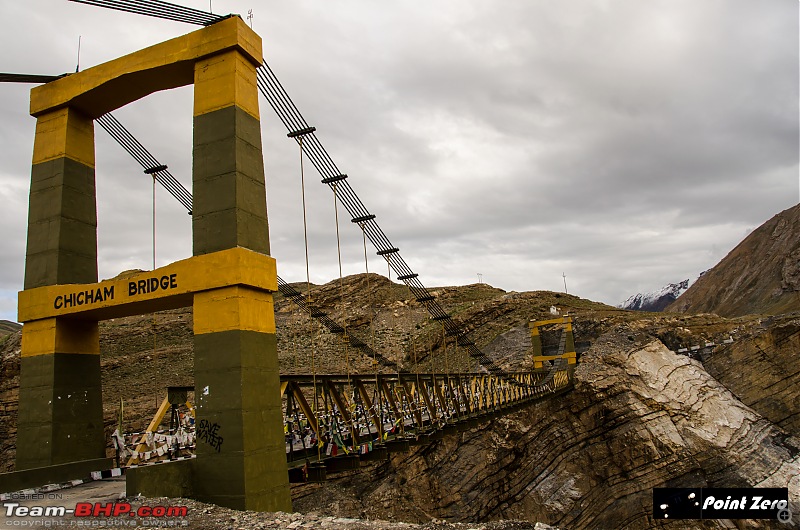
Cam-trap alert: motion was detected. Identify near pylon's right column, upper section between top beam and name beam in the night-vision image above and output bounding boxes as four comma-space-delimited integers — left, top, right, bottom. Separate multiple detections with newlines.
192, 51, 269, 256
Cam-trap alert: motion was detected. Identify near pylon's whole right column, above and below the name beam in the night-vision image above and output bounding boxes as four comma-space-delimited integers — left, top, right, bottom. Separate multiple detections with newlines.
192, 46, 291, 511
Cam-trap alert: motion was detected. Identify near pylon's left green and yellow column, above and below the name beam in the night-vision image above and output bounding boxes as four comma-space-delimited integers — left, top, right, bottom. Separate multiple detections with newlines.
17, 108, 105, 470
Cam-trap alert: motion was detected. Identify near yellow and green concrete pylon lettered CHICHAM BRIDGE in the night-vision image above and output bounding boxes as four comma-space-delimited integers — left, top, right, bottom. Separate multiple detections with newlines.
8, 16, 291, 511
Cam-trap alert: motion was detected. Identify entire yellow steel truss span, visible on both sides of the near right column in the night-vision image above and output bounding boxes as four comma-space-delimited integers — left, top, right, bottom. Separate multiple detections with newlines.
115, 362, 575, 470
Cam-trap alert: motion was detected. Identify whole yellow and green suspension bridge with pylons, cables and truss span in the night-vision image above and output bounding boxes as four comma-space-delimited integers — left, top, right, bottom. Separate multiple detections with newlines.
0, 0, 577, 511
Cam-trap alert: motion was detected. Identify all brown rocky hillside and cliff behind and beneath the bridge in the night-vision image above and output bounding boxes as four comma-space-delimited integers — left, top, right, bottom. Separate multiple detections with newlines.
0, 275, 800, 528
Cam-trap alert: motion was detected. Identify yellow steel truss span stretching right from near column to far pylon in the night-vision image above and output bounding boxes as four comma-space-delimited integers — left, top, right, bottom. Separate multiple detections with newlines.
288, 363, 574, 466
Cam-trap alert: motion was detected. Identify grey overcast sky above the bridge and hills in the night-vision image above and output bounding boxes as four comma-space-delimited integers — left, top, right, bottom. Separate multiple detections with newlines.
0, 0, 799, 320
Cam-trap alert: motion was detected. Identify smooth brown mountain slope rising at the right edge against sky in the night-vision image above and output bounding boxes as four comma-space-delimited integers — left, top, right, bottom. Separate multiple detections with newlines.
666, 205, 800, 317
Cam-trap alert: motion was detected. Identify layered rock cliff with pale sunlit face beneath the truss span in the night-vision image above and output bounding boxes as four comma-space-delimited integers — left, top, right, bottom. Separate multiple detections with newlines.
295, 325, 800, 528
